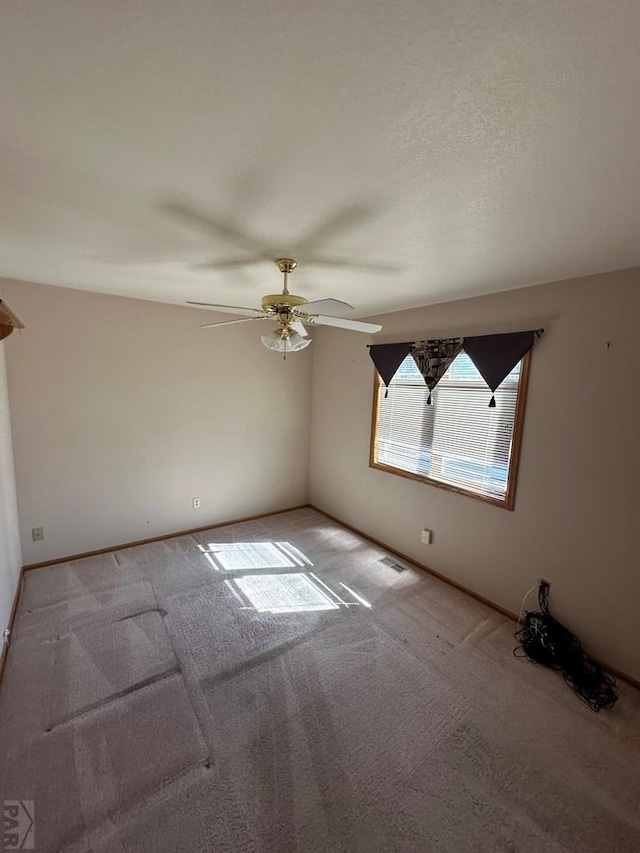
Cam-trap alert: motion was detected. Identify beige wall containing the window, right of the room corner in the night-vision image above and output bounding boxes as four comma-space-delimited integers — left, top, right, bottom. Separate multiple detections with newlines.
310, 270, 640, 678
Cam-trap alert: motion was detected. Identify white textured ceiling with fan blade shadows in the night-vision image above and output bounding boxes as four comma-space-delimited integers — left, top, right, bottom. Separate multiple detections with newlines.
0, 0, 640, 315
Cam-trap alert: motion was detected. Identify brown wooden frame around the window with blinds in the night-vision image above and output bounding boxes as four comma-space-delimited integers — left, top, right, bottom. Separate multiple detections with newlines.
369, 352, 531, 511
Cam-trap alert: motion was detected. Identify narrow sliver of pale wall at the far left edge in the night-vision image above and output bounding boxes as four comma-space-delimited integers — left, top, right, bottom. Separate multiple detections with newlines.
0, 333, 22, 643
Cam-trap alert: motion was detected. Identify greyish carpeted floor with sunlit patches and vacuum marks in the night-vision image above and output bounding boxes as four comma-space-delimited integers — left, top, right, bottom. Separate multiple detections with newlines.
0, 509, 640, 853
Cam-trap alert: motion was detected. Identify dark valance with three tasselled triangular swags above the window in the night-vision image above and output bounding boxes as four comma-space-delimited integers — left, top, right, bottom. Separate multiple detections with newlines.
369, 329, 544, 408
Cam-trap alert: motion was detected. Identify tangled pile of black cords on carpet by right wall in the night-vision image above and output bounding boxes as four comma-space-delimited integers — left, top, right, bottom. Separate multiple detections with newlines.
513, 581, 618, 711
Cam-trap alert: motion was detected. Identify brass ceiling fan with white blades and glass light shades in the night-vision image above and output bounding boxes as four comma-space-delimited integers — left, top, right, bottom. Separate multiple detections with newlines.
187, 258, 382, 358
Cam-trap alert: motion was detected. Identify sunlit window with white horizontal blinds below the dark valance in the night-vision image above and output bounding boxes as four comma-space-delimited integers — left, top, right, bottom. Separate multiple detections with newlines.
370, 352, 529, 509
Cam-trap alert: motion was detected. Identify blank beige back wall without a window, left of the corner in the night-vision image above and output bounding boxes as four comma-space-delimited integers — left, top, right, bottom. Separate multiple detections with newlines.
4, 282, 311, 563
